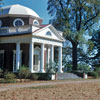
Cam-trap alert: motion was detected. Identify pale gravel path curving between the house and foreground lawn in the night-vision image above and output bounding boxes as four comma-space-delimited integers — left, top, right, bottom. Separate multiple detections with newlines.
0, 79, 100, 92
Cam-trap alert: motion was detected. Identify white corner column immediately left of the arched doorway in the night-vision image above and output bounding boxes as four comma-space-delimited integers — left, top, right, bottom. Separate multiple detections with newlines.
29, 42, 34, 73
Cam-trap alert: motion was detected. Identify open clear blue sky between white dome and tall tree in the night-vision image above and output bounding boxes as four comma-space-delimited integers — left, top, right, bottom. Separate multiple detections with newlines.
3, 0, 50, 24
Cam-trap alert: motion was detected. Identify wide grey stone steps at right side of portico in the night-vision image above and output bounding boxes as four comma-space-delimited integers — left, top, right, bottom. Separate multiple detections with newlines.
56, 73, 81, 80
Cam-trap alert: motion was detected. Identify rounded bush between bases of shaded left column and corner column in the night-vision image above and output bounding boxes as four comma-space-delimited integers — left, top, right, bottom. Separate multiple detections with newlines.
18, 66, 31, 81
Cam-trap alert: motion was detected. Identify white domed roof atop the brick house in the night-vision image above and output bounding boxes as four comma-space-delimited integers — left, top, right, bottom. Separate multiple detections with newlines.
0, 4, 40, 18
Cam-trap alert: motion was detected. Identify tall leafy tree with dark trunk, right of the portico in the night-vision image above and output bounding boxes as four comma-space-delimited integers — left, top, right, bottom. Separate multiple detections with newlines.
47, 0, 100, 70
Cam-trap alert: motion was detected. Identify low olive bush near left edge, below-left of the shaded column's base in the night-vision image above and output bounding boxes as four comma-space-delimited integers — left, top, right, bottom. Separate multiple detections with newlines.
4, 72, 16, 83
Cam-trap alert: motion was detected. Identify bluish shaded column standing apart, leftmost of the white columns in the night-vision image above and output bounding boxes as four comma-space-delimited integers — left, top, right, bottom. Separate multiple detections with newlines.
16, 42, 20, 71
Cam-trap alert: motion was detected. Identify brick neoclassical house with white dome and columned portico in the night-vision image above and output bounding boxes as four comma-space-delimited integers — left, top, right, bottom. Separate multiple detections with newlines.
0, 4, 64, 73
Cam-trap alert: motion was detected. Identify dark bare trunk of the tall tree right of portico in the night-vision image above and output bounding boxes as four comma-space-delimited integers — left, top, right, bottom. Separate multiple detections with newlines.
72, 42, 78, 70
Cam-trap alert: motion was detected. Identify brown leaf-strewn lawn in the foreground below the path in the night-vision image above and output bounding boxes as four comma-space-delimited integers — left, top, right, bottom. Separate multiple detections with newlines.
0, 82, 100, 100
